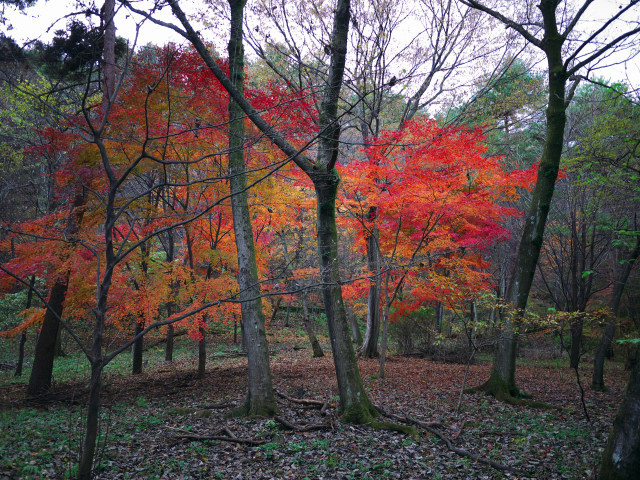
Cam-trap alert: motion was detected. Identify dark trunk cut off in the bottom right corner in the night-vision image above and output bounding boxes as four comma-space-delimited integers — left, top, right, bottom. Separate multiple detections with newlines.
598, 348, 640, 480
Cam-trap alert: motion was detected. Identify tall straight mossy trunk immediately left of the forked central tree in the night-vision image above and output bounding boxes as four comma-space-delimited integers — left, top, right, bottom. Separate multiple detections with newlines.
228, 0, 278, 416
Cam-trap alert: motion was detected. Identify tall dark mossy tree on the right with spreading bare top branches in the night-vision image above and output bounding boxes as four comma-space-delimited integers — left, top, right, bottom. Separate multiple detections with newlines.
461, 0, 640, 401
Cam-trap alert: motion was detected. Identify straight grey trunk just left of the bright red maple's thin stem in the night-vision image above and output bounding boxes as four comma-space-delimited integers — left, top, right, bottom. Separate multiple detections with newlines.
360, 225, 380, 358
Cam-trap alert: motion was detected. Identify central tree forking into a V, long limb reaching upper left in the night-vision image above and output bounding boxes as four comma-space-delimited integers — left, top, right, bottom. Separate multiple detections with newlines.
146, 0, 378, 423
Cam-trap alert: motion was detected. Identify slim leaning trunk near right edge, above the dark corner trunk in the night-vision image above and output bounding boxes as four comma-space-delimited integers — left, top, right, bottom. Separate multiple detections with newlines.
591, 236, 640, 392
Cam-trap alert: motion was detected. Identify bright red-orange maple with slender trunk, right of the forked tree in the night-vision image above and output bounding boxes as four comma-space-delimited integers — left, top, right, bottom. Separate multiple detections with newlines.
342, 117, 535, 375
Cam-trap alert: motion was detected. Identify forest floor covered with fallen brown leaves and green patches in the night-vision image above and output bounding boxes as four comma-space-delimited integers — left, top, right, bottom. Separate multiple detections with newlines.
0, 339, 628, 480
